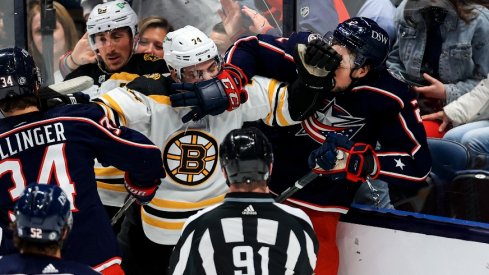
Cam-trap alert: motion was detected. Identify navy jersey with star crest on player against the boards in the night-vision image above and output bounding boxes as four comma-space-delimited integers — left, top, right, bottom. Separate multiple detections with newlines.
226, 32, 431, 213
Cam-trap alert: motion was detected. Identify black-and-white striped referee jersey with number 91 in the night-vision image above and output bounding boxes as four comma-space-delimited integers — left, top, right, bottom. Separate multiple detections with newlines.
170, 192, 318, 275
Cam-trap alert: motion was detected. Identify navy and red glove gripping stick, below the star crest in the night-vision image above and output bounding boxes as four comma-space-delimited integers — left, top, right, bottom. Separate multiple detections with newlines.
308, 133, 380, 182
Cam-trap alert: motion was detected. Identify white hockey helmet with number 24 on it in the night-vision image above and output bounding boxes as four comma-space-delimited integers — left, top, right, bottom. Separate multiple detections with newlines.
163, 26, 219, 79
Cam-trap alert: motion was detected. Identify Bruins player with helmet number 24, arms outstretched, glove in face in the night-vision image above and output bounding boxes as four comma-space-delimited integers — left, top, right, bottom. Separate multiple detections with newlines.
96, 26, 332, 274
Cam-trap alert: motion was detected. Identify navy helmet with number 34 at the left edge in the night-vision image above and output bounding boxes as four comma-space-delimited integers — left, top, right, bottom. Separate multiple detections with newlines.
0, 47, 41, 100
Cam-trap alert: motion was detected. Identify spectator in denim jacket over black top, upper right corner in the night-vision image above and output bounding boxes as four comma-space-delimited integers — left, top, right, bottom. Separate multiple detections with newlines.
387, 0, 489, 136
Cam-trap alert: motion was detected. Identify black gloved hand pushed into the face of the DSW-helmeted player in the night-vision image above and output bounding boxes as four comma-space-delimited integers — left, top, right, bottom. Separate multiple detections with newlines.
294, 39, 342, 91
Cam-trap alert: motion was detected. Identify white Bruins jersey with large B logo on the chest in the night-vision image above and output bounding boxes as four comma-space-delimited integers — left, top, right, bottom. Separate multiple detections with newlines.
93, 77, 298, 245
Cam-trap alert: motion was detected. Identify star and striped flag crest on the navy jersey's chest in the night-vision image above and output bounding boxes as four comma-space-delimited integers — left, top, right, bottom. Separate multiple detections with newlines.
296, 99, 365, 144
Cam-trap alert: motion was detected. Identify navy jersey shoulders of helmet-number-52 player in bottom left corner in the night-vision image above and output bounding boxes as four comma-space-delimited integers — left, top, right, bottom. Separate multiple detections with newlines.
0, 254, 100, 275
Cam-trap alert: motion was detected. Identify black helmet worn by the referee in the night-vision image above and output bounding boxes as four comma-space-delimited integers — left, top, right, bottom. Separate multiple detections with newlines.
219, 127, 273, 184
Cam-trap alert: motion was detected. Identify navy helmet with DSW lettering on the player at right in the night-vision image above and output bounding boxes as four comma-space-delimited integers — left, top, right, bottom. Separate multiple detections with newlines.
333, 17, 390, 69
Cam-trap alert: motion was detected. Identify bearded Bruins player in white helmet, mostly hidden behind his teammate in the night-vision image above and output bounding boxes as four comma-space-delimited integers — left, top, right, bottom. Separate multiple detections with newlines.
60, 0, 168, 232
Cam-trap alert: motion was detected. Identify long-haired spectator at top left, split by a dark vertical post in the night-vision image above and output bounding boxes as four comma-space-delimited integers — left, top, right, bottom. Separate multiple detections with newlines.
27, 1, 78, 82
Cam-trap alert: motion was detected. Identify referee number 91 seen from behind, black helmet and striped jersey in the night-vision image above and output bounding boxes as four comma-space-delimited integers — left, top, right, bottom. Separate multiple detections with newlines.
170, 128, 318, 275
